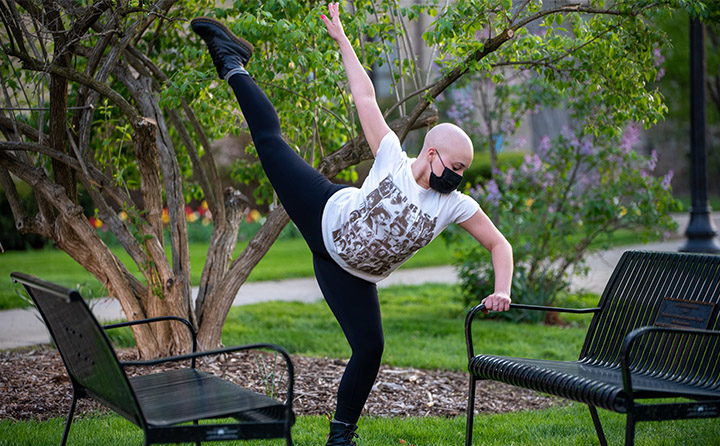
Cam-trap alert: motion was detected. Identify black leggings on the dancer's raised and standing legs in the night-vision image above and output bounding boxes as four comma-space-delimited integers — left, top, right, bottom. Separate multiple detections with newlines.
228, 74, 385, 424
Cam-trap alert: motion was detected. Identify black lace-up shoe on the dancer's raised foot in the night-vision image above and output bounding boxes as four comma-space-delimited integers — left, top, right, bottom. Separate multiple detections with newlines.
190, 17, 254, 80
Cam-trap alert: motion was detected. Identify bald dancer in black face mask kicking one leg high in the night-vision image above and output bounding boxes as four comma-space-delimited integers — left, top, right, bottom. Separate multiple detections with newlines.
191, 3, 513, 446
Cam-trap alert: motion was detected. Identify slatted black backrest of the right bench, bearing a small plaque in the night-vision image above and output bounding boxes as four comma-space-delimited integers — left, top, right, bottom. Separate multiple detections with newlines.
580, 251, 720, 388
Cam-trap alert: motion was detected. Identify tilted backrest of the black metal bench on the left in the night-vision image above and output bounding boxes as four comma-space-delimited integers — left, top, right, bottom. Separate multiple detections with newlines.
12, 273, 144, 427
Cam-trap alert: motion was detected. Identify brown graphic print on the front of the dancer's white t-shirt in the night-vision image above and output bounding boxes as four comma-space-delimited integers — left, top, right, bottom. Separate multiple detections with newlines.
332, 175, 437, 276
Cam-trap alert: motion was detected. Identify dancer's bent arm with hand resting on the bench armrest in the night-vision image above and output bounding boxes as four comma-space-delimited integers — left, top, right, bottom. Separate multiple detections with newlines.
460, 210, 513, 311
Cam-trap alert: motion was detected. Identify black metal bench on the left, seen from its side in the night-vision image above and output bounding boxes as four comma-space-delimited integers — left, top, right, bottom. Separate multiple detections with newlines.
11, 272, 295, 445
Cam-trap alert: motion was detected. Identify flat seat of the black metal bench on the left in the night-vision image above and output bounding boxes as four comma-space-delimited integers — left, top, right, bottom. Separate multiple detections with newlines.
130, 369, 285, 426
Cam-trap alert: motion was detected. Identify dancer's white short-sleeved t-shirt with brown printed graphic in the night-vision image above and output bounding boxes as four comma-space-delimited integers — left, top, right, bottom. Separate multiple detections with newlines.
322, 132, 480, 282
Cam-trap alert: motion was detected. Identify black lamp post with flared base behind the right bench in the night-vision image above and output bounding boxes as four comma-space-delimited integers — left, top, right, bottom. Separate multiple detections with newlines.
680, 18, 720, 254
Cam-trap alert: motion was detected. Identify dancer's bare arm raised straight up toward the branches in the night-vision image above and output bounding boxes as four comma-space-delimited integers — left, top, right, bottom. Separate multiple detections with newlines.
322, 3, 391, 156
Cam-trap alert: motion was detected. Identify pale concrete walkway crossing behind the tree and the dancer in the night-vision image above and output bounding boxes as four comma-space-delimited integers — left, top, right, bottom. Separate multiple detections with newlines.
0, 212, 720, 349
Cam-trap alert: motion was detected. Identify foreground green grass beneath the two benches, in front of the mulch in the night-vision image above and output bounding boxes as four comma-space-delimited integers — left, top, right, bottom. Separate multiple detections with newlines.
0, 405, 720, 446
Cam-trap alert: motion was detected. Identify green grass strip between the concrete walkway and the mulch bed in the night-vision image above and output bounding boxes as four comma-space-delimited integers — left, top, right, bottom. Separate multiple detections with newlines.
223, 284, 597, 371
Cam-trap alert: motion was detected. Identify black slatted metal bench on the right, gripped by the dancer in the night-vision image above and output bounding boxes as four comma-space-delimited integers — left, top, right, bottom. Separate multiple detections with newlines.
465, 251, 720, 446
